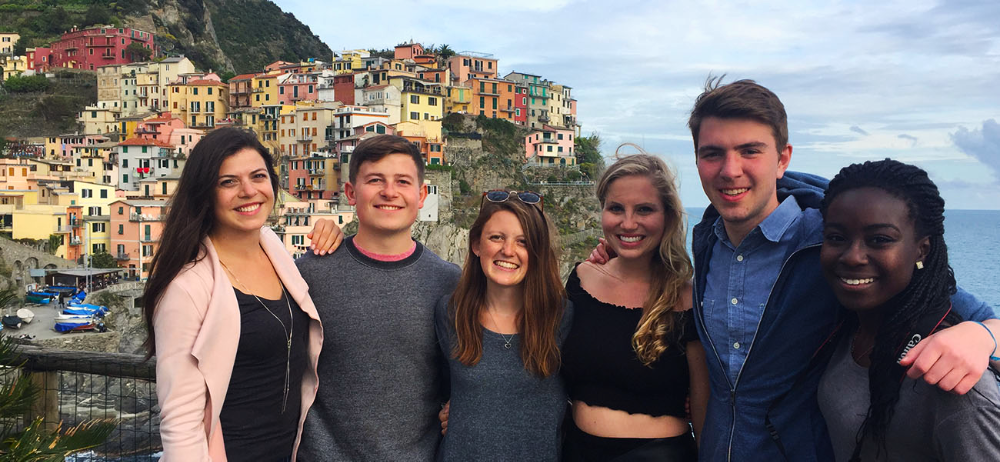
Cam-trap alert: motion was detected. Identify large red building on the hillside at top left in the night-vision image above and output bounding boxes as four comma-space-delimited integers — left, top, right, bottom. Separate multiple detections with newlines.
46, 26, 154, 71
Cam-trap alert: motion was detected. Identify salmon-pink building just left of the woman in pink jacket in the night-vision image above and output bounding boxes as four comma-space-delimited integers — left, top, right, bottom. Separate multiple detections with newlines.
108, 200, 167, 280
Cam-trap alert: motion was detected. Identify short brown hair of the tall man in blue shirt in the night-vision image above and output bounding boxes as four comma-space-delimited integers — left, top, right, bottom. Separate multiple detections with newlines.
688, 75, 788, 152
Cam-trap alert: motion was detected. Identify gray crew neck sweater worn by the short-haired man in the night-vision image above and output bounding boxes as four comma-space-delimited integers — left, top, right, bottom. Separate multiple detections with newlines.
296, 238, 460, 462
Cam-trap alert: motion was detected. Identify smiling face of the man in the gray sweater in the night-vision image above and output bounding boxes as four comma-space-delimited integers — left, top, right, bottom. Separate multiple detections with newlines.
344, 154, 427, 242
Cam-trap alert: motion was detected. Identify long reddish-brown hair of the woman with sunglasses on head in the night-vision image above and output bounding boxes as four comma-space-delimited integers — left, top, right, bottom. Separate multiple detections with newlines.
448, 197, 566, 377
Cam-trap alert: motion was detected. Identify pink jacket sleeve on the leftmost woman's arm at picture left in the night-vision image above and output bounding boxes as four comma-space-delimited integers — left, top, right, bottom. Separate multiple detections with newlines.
153, 281, 211, 462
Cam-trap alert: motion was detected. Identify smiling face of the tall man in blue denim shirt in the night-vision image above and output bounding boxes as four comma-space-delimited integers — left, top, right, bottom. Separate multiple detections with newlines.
696, 117, 792, 242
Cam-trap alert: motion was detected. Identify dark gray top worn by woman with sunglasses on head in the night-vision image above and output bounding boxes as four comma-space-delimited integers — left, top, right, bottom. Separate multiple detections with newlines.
434, 296, 573, 462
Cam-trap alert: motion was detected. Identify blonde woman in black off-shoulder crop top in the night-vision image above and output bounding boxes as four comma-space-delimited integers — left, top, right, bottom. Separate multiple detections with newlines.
562, 154, 708, 461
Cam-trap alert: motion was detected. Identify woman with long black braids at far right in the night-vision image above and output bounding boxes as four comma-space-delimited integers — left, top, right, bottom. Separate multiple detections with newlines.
818, 159, 1000, 461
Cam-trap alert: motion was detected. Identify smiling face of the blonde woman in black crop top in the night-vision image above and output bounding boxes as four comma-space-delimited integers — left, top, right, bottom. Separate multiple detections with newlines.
601, 175, 666, 259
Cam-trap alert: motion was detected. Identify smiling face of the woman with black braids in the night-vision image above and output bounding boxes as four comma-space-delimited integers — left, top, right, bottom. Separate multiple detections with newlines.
820, 187, 930, 311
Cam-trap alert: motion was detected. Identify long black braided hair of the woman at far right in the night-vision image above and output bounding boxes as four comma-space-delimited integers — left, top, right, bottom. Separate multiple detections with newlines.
820, 159, 961, 461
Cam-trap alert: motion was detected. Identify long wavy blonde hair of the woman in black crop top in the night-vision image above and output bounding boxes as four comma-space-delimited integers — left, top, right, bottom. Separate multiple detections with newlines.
597, 153, 694, 366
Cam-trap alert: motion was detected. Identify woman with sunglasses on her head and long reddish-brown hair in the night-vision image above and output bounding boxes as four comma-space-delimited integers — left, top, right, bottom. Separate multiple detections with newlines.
435, 191, 572, 461
